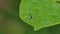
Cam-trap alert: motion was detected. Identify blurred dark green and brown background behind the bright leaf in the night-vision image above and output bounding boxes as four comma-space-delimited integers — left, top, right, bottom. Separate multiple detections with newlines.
0, 0, 60, 34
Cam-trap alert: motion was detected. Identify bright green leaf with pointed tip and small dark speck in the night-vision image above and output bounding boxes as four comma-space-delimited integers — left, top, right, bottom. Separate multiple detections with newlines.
19, 0, 60, 31
